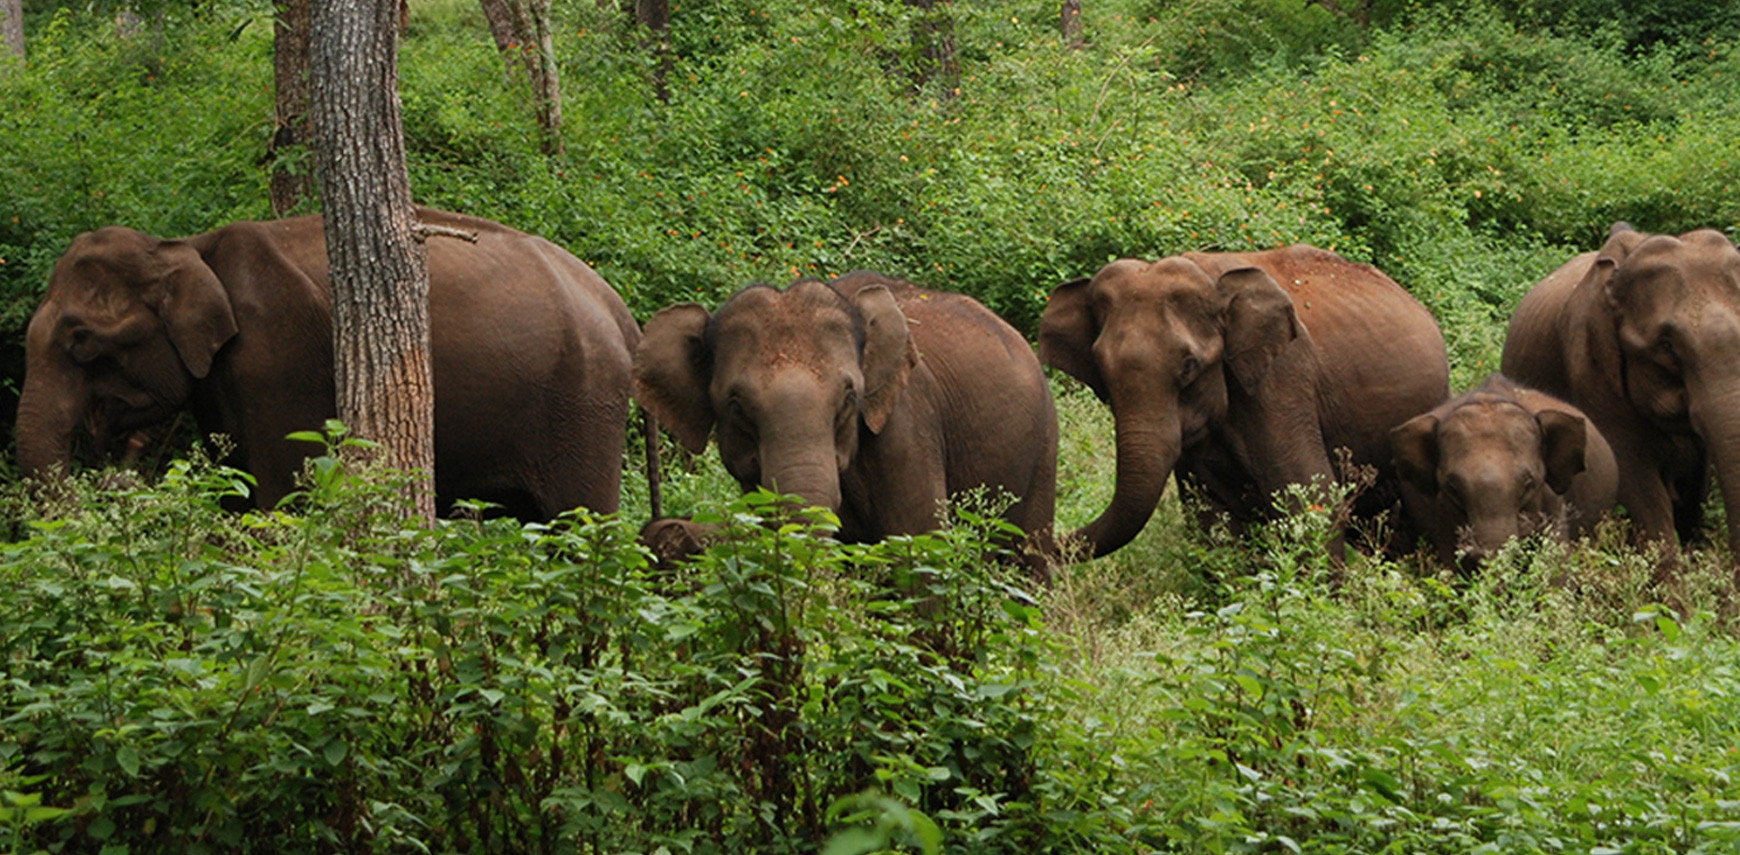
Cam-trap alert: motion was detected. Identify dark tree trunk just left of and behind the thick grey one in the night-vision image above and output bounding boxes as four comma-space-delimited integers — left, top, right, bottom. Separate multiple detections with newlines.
266, 0, 315, 216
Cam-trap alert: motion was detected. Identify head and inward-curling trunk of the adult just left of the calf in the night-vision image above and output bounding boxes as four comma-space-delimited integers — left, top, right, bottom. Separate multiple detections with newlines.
1039, 256, 1303, 557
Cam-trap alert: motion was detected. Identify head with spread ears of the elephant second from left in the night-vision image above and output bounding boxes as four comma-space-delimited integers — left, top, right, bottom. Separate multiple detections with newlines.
633, 279, 919, 510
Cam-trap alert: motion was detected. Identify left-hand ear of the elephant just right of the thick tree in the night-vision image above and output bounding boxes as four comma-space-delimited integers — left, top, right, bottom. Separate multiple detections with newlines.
633, 303, 713, 454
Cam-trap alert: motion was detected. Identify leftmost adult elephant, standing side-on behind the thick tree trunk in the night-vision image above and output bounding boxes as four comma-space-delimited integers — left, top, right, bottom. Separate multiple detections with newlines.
17, 209, 640, 519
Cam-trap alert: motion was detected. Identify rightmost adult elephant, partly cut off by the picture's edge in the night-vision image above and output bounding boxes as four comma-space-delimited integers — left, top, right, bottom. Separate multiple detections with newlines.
1503, 223, 1740, 564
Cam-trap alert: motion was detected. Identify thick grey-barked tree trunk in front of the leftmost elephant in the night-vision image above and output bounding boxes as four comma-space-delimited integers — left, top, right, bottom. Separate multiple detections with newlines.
310, 0, 435, 521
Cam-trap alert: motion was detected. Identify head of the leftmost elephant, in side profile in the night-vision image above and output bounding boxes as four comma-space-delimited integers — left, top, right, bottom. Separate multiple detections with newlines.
17, 226, 237, 477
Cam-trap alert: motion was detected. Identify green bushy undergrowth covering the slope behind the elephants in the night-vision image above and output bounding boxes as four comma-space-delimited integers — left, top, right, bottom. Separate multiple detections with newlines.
0, 0, 1740, 463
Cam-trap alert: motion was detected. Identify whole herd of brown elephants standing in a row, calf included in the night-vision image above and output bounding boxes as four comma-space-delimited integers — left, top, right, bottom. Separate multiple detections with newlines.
17, 209, 1740, 575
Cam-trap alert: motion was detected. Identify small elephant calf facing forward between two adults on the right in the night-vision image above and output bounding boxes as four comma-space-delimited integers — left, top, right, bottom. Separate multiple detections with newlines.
1390, 374, 1618, 569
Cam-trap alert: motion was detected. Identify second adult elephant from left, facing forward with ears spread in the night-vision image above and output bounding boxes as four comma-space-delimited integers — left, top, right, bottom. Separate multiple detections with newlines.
633, 272, 1058, 560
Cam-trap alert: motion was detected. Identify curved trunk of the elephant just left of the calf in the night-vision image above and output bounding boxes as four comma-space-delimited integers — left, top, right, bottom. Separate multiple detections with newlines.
1070, 395, 1183, 557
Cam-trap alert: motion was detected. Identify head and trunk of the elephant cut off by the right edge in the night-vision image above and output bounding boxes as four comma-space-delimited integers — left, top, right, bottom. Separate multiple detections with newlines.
1585, 223, 1740, 547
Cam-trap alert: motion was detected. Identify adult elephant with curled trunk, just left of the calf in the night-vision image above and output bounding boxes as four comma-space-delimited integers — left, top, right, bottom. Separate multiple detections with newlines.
1039, 244, 1449, 555
